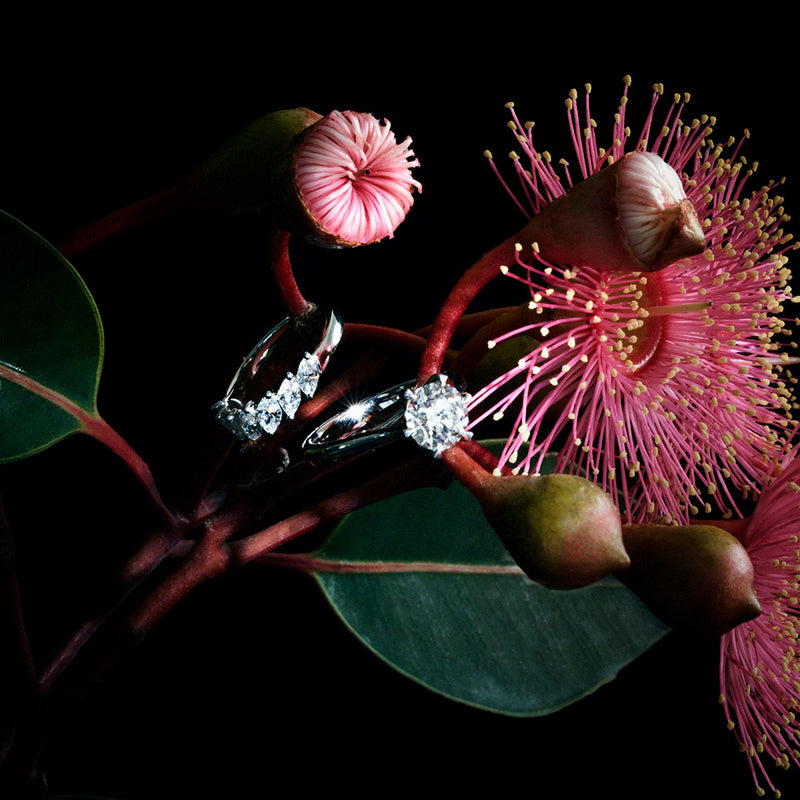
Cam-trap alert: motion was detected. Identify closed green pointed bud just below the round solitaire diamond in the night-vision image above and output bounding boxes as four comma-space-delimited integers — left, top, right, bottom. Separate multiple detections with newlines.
479, 474, 629, 589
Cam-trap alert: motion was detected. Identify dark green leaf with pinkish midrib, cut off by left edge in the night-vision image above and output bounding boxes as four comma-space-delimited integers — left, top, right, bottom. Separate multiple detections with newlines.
0, 211, 103, 463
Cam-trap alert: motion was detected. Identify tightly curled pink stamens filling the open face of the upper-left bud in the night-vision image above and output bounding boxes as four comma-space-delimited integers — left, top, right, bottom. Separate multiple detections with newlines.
294, 111, 422, 246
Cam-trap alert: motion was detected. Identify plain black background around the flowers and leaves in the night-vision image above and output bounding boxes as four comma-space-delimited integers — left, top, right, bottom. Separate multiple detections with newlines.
0, 15, 800, 800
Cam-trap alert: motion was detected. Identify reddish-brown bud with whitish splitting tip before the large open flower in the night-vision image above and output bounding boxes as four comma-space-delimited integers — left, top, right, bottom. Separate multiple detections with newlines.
517, 151, 705, 271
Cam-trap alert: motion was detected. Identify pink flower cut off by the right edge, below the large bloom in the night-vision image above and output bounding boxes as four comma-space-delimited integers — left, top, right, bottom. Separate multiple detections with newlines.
720, 447, 800, 797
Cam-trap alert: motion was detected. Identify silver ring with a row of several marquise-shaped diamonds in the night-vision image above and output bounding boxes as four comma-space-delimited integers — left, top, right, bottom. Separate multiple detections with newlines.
213, 304, 343, 442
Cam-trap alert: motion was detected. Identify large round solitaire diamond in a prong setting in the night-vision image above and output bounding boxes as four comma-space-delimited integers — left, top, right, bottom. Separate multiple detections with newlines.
405, 375, 471, 456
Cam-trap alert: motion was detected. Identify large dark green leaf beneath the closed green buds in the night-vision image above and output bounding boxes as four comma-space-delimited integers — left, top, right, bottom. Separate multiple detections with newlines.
313, 454, 668, 716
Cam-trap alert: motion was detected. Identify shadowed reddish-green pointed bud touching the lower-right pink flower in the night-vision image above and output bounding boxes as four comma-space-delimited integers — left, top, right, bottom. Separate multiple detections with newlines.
618, 524, 761, 636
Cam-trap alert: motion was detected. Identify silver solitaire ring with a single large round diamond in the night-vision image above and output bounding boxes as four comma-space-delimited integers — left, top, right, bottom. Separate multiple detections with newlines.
303, 375, 472, 463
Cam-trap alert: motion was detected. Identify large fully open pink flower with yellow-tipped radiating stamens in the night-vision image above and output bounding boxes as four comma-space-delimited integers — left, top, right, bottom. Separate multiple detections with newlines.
470, 76, 791, 523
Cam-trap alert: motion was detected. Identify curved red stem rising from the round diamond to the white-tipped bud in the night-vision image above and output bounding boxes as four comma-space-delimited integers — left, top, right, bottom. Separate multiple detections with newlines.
417, 238, 516, 385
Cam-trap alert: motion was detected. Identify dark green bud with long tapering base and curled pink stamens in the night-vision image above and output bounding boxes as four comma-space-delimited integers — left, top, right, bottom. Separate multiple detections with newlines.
59, 108, 422, 257
